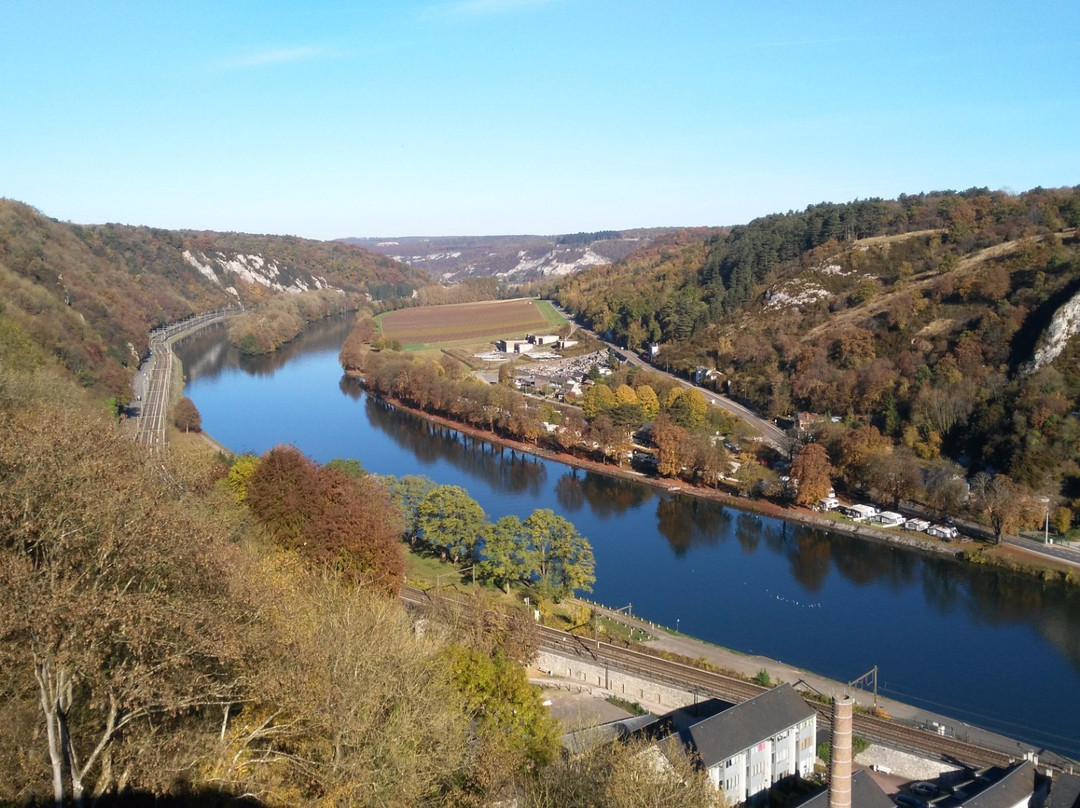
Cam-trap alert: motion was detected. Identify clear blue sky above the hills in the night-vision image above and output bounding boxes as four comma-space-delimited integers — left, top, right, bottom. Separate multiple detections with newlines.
0, 0, 1080, 239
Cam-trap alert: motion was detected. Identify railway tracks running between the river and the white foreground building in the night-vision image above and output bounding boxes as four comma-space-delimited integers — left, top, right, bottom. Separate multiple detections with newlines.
401, 587, 1015, 768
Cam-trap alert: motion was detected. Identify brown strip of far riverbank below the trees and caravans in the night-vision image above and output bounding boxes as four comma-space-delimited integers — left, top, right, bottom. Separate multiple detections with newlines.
346, 372, 1080, 585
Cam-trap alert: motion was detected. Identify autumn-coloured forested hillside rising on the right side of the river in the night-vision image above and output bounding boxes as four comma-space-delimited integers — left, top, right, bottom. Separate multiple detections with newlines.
551, 188, 1080, 533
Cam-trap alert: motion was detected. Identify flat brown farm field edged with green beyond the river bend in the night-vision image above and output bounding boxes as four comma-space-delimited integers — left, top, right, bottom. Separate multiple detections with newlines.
378, 298, 565, 350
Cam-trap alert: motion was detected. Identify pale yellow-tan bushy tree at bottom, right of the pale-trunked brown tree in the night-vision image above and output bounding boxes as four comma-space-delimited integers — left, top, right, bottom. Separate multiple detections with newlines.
203, 553, 471, 808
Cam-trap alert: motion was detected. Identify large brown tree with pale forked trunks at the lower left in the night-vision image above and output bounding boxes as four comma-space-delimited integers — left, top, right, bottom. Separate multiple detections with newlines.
0, 403, 245, 806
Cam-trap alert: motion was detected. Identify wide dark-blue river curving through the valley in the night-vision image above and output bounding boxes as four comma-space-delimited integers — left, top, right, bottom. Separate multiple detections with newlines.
176, 318, 1080, 758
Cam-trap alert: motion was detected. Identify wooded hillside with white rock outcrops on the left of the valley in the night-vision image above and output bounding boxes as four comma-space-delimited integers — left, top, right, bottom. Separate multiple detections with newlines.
0, 200, 430, 403
